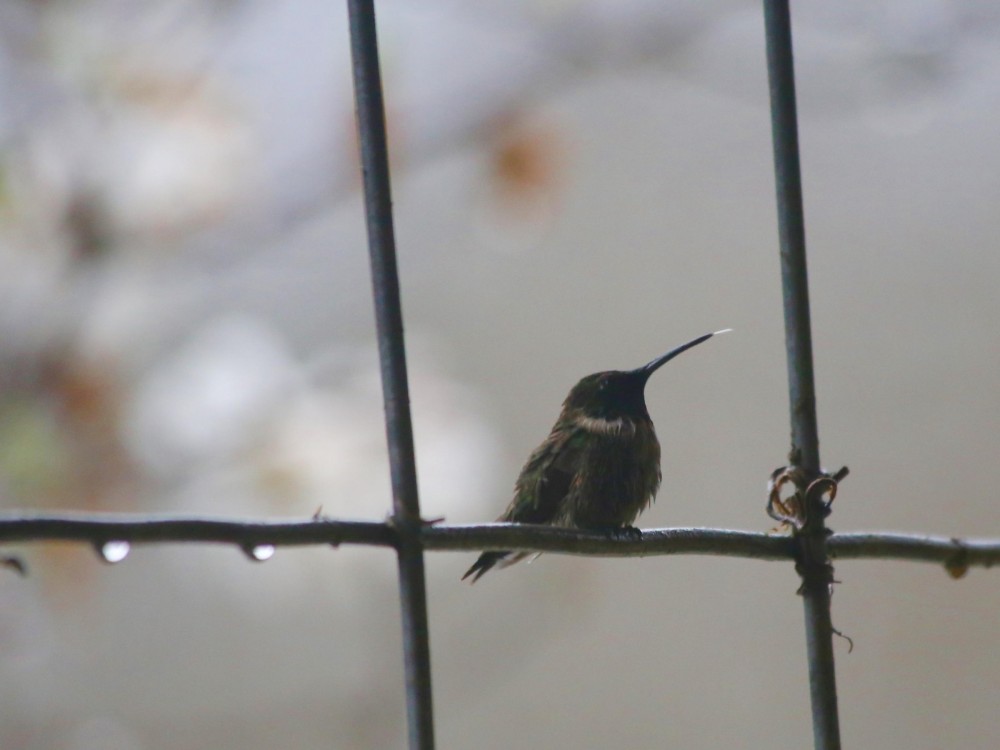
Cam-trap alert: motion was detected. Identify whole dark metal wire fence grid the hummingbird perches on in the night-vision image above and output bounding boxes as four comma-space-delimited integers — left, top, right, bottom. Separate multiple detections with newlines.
0, 0, 1000, 750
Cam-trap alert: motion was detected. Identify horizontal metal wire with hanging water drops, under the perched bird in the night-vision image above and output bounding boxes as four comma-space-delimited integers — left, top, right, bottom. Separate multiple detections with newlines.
0, 513, 1000, 570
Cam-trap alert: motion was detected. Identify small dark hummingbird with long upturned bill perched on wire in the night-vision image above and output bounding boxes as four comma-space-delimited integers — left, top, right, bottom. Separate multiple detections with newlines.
462, 328, 731, 583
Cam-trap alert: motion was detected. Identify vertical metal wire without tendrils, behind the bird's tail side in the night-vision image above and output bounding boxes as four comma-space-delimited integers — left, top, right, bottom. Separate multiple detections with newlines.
347, 0, 434, 750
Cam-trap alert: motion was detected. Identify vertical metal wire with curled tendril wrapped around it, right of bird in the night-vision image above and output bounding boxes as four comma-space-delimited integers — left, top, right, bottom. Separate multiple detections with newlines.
764, 0, 840, 750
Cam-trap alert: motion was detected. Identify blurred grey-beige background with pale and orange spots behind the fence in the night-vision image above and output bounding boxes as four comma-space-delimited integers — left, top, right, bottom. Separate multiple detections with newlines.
0, 0, 1000, 750
